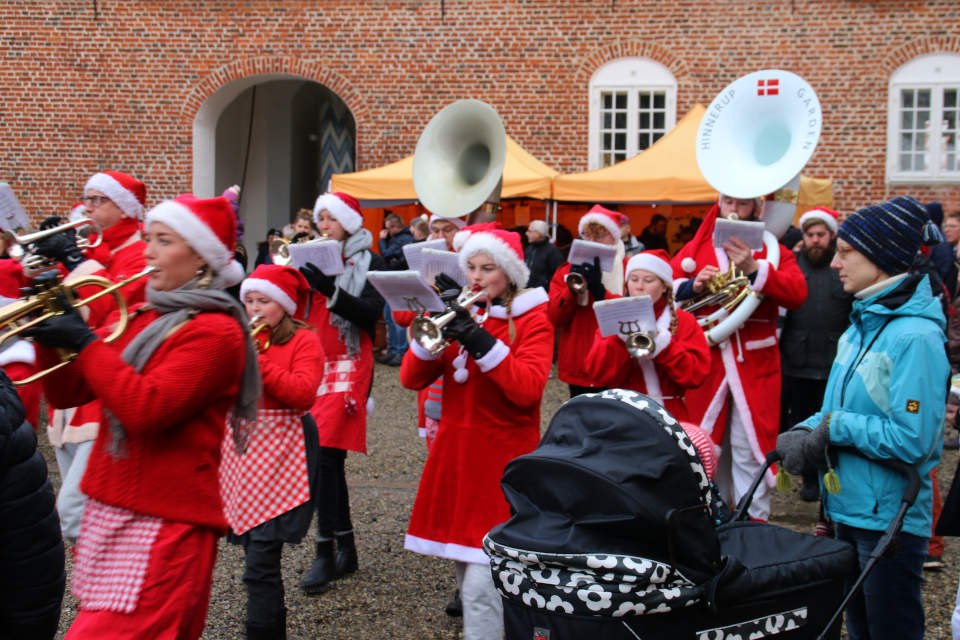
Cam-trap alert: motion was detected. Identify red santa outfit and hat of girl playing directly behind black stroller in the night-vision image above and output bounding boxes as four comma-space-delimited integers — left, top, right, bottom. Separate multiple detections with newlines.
586, 249, 710, 422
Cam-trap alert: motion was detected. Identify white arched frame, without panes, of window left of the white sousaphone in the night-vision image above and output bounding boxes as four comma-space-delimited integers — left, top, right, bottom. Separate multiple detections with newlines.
587, 57, 677, 170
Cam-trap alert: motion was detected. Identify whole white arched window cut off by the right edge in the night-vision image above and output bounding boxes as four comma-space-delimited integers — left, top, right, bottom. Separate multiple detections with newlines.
887, 53, 960, 183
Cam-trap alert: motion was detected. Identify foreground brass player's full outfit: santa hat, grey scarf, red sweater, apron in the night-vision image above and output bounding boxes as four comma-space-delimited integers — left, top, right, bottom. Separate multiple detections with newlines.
31, 195, 253, 640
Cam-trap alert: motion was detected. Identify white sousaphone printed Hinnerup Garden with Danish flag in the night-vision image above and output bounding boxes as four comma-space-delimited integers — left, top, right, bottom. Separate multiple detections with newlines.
684, 69, 822, 346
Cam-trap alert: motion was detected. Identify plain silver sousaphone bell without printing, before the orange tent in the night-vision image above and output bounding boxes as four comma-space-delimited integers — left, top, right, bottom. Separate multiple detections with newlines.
413, 100, 507, 224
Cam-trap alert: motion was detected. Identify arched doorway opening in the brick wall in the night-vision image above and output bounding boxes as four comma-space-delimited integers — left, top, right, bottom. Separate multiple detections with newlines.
194, 74, 357, 268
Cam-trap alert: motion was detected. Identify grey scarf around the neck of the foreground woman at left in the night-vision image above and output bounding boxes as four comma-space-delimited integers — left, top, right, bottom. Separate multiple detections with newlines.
107, 276, 260, 459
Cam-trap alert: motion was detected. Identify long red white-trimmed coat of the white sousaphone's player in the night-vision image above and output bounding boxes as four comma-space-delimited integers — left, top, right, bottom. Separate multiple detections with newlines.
672, 205, 807, 483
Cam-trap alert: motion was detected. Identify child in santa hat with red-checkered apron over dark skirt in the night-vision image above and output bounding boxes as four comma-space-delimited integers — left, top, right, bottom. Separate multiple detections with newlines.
220, 265, 323, 638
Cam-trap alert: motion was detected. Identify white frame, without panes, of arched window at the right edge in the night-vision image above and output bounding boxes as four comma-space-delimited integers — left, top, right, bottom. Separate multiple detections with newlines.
886, 53, 960, 184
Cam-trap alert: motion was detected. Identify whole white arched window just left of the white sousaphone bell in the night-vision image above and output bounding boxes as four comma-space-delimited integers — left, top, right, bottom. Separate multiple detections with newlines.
589, 58, 677, 169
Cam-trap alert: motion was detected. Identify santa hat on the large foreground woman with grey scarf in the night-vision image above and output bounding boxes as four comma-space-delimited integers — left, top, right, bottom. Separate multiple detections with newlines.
146, 193, 245, 287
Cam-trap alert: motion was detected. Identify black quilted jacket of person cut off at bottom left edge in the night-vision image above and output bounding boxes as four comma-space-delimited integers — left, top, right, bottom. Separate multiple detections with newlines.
0, 370, 67, 638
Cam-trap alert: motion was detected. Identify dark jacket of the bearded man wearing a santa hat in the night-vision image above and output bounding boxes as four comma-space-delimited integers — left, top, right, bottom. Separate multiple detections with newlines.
780, 253, 853, 380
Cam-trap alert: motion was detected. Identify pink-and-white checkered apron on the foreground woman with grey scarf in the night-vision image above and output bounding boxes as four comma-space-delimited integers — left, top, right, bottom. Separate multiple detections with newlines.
70, 499, 163, 613
